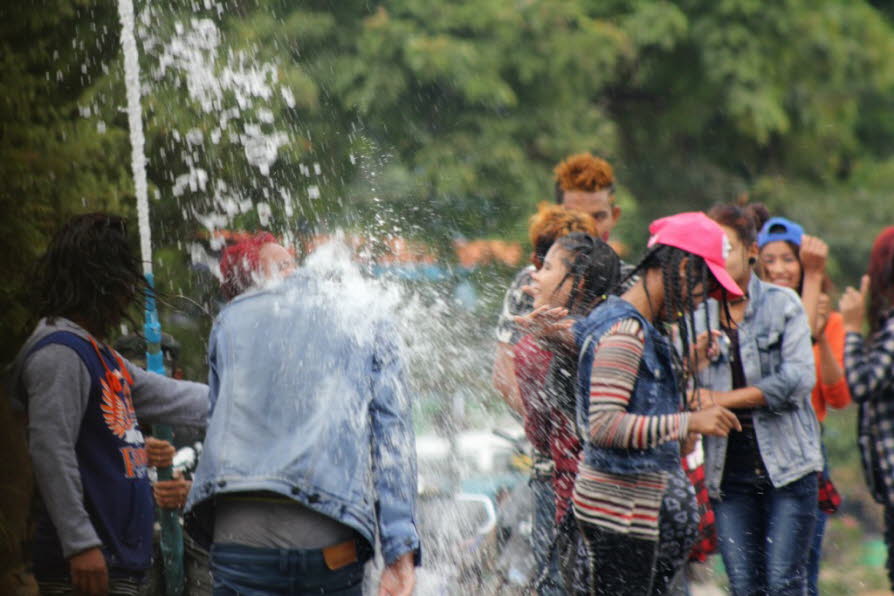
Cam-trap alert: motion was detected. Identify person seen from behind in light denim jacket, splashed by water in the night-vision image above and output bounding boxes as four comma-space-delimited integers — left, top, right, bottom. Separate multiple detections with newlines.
186, 241, 420, 595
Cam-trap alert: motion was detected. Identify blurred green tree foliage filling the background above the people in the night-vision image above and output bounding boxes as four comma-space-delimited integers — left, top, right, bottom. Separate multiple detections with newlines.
0, 0, 894, 356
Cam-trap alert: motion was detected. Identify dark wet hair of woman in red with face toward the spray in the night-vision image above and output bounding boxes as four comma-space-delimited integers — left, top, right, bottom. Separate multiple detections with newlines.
556, 232, 621, 315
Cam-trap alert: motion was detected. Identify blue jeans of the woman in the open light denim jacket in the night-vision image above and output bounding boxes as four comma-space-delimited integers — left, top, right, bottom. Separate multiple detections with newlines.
711, 472, 817, 596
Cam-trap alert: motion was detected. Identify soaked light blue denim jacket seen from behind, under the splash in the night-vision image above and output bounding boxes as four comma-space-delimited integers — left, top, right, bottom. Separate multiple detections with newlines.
186, 271, 419, 563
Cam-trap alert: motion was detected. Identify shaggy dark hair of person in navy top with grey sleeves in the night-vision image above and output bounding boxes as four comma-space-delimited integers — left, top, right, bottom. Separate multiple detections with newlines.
35, 213, 147, 337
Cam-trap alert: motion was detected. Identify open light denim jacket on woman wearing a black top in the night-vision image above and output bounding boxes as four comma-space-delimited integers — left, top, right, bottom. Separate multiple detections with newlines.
695, 275, 823, 499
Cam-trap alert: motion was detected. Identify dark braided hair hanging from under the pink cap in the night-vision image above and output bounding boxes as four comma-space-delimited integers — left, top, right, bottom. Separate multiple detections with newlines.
622, 244, 729, 393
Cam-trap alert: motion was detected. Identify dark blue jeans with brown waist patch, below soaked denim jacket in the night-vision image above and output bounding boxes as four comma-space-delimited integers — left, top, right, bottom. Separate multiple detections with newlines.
211, 544, 366, 596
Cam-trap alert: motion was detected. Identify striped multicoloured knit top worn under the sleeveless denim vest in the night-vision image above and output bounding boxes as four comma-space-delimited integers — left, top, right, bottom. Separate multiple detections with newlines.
573, 318, 689, 540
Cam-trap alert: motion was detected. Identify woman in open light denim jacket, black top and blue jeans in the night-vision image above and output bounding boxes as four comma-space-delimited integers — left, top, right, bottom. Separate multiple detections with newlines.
692, 206, 823, 595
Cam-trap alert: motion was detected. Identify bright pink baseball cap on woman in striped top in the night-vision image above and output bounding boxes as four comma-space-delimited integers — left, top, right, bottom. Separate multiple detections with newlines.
648, 211, 743, 298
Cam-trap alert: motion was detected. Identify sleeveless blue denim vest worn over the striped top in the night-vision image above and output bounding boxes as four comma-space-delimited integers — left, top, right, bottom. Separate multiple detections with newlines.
574, 296, 682, 474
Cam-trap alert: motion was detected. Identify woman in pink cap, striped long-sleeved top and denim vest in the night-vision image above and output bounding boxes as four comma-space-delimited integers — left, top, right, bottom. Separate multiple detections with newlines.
573, 213, 742, 596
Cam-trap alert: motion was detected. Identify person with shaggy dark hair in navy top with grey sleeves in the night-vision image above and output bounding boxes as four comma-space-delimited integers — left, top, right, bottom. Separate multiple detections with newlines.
11, 213, 209, 595
